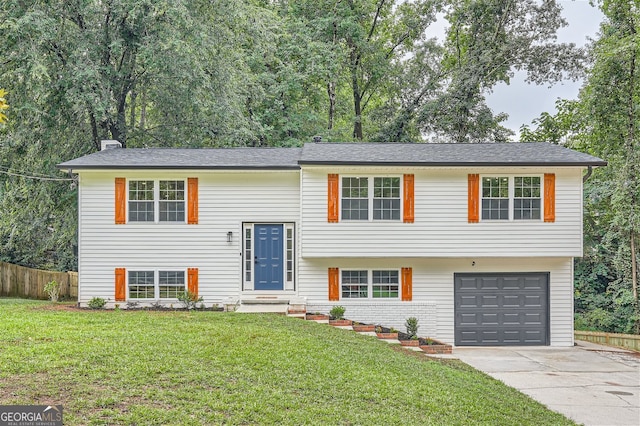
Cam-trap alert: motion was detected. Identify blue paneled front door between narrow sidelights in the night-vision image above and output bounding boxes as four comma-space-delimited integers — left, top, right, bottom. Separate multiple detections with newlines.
254, 225, 284, 290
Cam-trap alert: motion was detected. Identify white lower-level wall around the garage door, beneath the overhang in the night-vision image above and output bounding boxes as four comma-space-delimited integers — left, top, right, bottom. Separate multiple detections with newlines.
299, 258, 573, 346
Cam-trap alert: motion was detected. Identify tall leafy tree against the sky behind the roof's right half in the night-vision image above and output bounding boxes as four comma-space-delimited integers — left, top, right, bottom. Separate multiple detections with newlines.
396, 0, 583, 142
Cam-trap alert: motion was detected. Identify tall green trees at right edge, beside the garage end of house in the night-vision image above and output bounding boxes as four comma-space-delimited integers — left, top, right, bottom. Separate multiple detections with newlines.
525, 1, 640, 333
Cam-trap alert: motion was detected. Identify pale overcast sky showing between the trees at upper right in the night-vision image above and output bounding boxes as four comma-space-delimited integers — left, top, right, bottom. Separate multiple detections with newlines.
487, 0, 603, 139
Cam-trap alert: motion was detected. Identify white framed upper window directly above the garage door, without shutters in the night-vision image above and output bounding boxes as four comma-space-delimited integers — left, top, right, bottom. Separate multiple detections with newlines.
480, 176, 543, 221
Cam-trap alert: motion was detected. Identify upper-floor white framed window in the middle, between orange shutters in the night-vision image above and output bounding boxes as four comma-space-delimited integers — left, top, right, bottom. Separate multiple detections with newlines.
340, 176, 402, 221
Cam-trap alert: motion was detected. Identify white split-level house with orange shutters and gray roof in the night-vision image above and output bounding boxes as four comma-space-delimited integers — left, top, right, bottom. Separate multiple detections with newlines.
59, 142, 606, 346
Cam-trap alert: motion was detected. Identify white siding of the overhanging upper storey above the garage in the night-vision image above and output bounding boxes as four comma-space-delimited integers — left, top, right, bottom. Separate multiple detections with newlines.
301, 167, 582, 257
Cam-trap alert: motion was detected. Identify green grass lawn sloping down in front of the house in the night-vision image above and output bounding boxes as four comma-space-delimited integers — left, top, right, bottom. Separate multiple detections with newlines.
0, 299, 572, 425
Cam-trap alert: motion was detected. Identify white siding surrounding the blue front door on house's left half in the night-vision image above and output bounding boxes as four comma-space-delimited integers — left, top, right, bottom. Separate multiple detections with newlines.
78, 171, 300, 304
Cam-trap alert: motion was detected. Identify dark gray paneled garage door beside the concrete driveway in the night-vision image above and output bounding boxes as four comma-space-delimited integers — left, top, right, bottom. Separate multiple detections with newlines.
454, 272, 549, 346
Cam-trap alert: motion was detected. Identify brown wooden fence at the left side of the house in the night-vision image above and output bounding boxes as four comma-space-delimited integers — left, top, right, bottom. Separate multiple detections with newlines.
0, 262, 78, 300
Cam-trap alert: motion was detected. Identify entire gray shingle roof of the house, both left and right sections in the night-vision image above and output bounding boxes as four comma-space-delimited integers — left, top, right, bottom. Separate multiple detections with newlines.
58, 142, 607, 170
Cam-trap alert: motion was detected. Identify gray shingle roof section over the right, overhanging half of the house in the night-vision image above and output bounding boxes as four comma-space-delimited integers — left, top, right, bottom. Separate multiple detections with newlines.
300, 142, 606, 166
